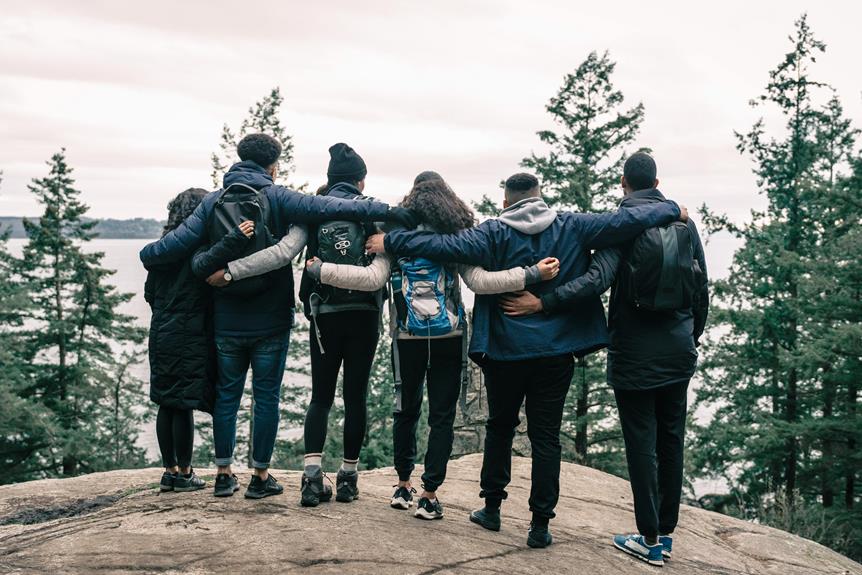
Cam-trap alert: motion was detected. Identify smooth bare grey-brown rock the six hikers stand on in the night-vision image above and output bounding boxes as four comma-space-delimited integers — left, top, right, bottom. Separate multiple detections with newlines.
0, 455, 862, 575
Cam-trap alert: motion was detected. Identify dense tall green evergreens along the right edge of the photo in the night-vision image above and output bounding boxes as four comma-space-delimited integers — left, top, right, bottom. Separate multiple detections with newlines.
693, 16, 862, 559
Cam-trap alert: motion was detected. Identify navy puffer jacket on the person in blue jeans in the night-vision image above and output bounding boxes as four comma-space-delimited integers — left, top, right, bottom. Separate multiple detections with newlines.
140, 161, 389, 337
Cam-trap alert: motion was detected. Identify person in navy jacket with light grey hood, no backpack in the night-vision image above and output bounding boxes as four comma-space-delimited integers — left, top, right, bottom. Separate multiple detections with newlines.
367, 174, 686, 548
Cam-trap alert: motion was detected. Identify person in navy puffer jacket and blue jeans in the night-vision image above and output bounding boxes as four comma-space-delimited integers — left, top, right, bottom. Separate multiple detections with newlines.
140, 134, 417, 499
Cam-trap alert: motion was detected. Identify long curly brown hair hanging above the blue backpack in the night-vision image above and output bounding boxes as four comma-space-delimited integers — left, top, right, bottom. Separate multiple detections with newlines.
401, 172, 476, 234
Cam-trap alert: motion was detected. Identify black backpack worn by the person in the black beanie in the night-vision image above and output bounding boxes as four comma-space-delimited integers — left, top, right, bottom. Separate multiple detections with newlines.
315, 216, 378, 304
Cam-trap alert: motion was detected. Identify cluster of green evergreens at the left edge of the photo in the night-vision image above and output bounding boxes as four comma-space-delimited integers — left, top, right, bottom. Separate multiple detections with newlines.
0, 151, 145, 480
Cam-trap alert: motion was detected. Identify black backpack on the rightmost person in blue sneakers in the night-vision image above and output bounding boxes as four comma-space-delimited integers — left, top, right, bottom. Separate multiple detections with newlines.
619, 221, 701, 311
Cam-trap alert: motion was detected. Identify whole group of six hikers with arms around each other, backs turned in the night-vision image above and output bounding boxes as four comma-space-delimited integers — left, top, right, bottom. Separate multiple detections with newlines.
140, 134, 708, 565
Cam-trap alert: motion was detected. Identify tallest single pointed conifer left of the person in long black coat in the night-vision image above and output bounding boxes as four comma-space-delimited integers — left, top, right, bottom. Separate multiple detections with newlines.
16, 150, 144, 475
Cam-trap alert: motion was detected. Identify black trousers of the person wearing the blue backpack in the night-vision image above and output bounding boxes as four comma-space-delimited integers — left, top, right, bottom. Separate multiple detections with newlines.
392, 335, 464, 491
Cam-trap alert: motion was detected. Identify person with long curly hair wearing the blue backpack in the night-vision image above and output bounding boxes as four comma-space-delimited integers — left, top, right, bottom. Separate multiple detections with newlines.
306, 171, 559, 519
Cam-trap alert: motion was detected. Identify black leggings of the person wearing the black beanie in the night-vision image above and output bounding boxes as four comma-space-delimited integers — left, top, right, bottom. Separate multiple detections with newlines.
305, 310, 380, 460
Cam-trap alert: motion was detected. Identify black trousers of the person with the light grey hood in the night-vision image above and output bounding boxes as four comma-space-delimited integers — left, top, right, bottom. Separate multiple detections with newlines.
479, 354, 575, 519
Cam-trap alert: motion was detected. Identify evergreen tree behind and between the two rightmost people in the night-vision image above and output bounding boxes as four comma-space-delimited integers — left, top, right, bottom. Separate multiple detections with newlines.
492, 52, 644, 475
